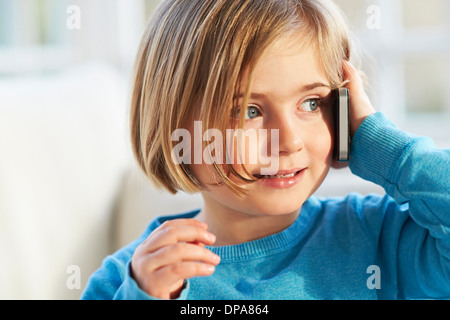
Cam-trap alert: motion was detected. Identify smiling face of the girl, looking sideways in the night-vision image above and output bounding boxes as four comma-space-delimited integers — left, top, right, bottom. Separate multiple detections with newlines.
192, 38, 333, 216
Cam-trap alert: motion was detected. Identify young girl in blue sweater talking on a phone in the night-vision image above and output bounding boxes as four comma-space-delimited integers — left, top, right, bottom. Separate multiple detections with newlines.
82, 0, 450, 299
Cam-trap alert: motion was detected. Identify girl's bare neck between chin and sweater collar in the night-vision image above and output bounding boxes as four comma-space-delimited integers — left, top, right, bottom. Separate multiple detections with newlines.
197, 195, 300, 246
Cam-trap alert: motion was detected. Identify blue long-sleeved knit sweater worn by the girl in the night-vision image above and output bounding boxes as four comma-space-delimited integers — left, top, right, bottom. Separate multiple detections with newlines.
82, 113, 450, 300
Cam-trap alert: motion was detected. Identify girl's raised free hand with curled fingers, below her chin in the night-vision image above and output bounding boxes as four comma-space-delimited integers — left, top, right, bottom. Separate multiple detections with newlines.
131, 219, 220, 299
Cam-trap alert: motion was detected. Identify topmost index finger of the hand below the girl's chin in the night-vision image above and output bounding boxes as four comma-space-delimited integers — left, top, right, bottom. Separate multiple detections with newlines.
139, 224, 216, 252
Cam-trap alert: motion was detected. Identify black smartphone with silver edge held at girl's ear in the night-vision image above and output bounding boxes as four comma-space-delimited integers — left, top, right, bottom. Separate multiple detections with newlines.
333, 88, 350, 162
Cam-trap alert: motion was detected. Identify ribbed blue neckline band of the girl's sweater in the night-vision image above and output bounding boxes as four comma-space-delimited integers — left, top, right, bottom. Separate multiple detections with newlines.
202, 198, 318, 263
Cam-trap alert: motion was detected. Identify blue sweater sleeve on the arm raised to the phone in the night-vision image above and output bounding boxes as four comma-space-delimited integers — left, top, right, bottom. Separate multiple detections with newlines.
349, 113, 450, 299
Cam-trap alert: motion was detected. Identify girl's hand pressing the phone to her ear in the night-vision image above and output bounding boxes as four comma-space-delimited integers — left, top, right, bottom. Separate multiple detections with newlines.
343, 61, 375, 138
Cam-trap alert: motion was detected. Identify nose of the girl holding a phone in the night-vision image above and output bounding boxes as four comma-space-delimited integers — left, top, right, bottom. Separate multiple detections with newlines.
268, 116, 304, 156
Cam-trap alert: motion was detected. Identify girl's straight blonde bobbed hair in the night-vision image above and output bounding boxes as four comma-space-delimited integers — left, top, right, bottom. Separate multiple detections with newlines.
130, 0, 350, 193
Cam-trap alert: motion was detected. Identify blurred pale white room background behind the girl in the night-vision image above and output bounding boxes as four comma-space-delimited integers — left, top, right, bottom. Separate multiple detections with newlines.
0, 0, 450, 299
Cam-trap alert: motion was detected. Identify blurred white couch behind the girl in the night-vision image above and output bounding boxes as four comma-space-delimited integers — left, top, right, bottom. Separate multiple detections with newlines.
0, 64, 384, 299
